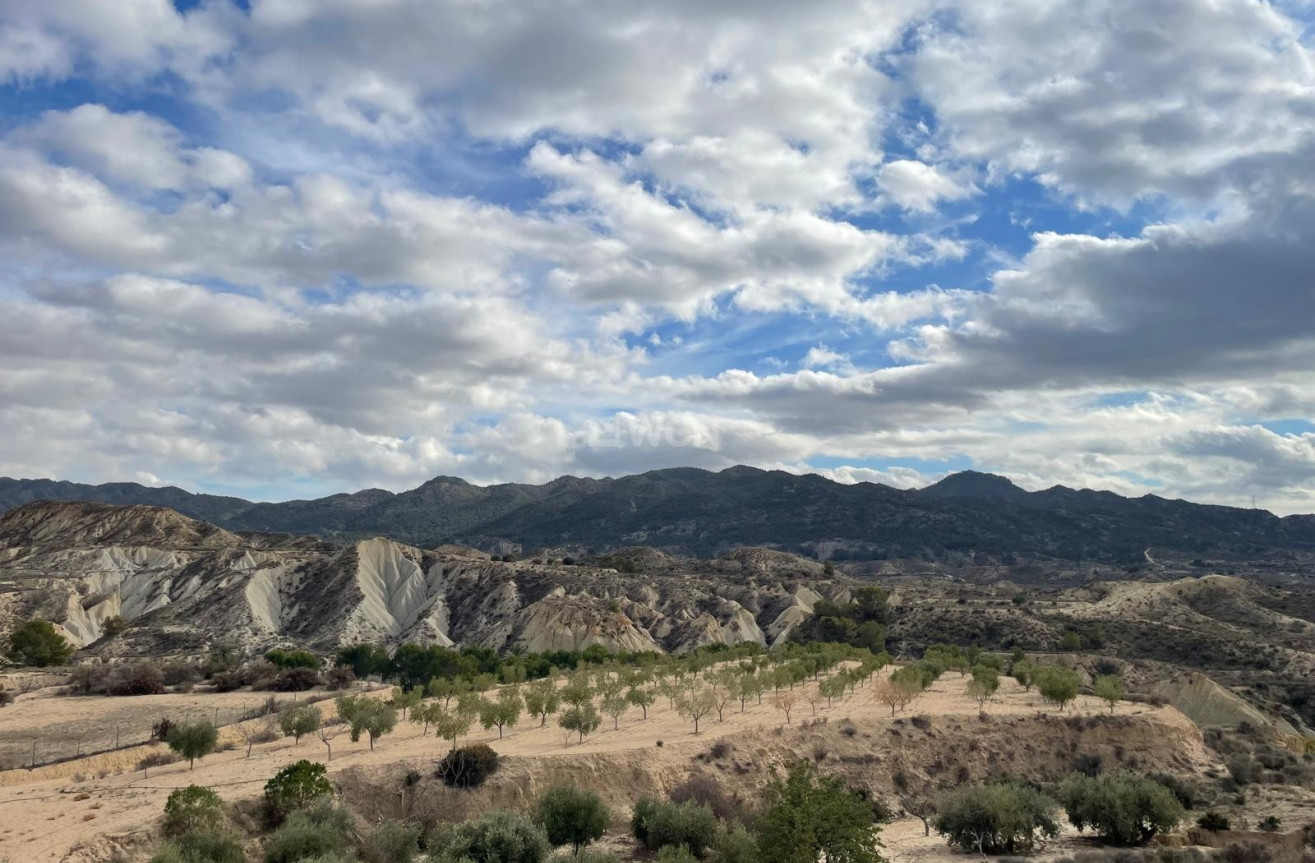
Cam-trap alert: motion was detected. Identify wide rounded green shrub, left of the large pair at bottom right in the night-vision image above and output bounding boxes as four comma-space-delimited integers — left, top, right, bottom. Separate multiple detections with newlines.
934, 783, 1059, 854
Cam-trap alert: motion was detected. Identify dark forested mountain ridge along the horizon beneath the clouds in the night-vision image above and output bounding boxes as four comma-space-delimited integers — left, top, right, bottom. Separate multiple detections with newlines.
0, 466, 1315, 562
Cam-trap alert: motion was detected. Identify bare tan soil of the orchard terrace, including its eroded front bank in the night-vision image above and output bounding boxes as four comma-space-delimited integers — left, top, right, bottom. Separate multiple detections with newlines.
0, 672, 1218, 863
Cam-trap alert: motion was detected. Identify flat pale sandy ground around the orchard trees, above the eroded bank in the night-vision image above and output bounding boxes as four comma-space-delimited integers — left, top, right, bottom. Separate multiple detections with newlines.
0, 672, 1186, 863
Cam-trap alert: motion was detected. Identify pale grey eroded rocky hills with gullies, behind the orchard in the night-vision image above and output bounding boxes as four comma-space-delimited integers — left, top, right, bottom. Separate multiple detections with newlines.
0, 501, 848, 655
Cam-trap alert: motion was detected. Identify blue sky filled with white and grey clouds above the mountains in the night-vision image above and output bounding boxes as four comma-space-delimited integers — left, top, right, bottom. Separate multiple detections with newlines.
0, 0, 1315, 513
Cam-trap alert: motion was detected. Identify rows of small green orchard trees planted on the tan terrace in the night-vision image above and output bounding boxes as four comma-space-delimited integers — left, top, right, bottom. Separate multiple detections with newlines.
156, 643, 1141, 778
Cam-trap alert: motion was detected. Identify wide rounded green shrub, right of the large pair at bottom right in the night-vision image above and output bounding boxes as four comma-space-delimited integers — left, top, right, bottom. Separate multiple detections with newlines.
1063, 772, 1184, 845
